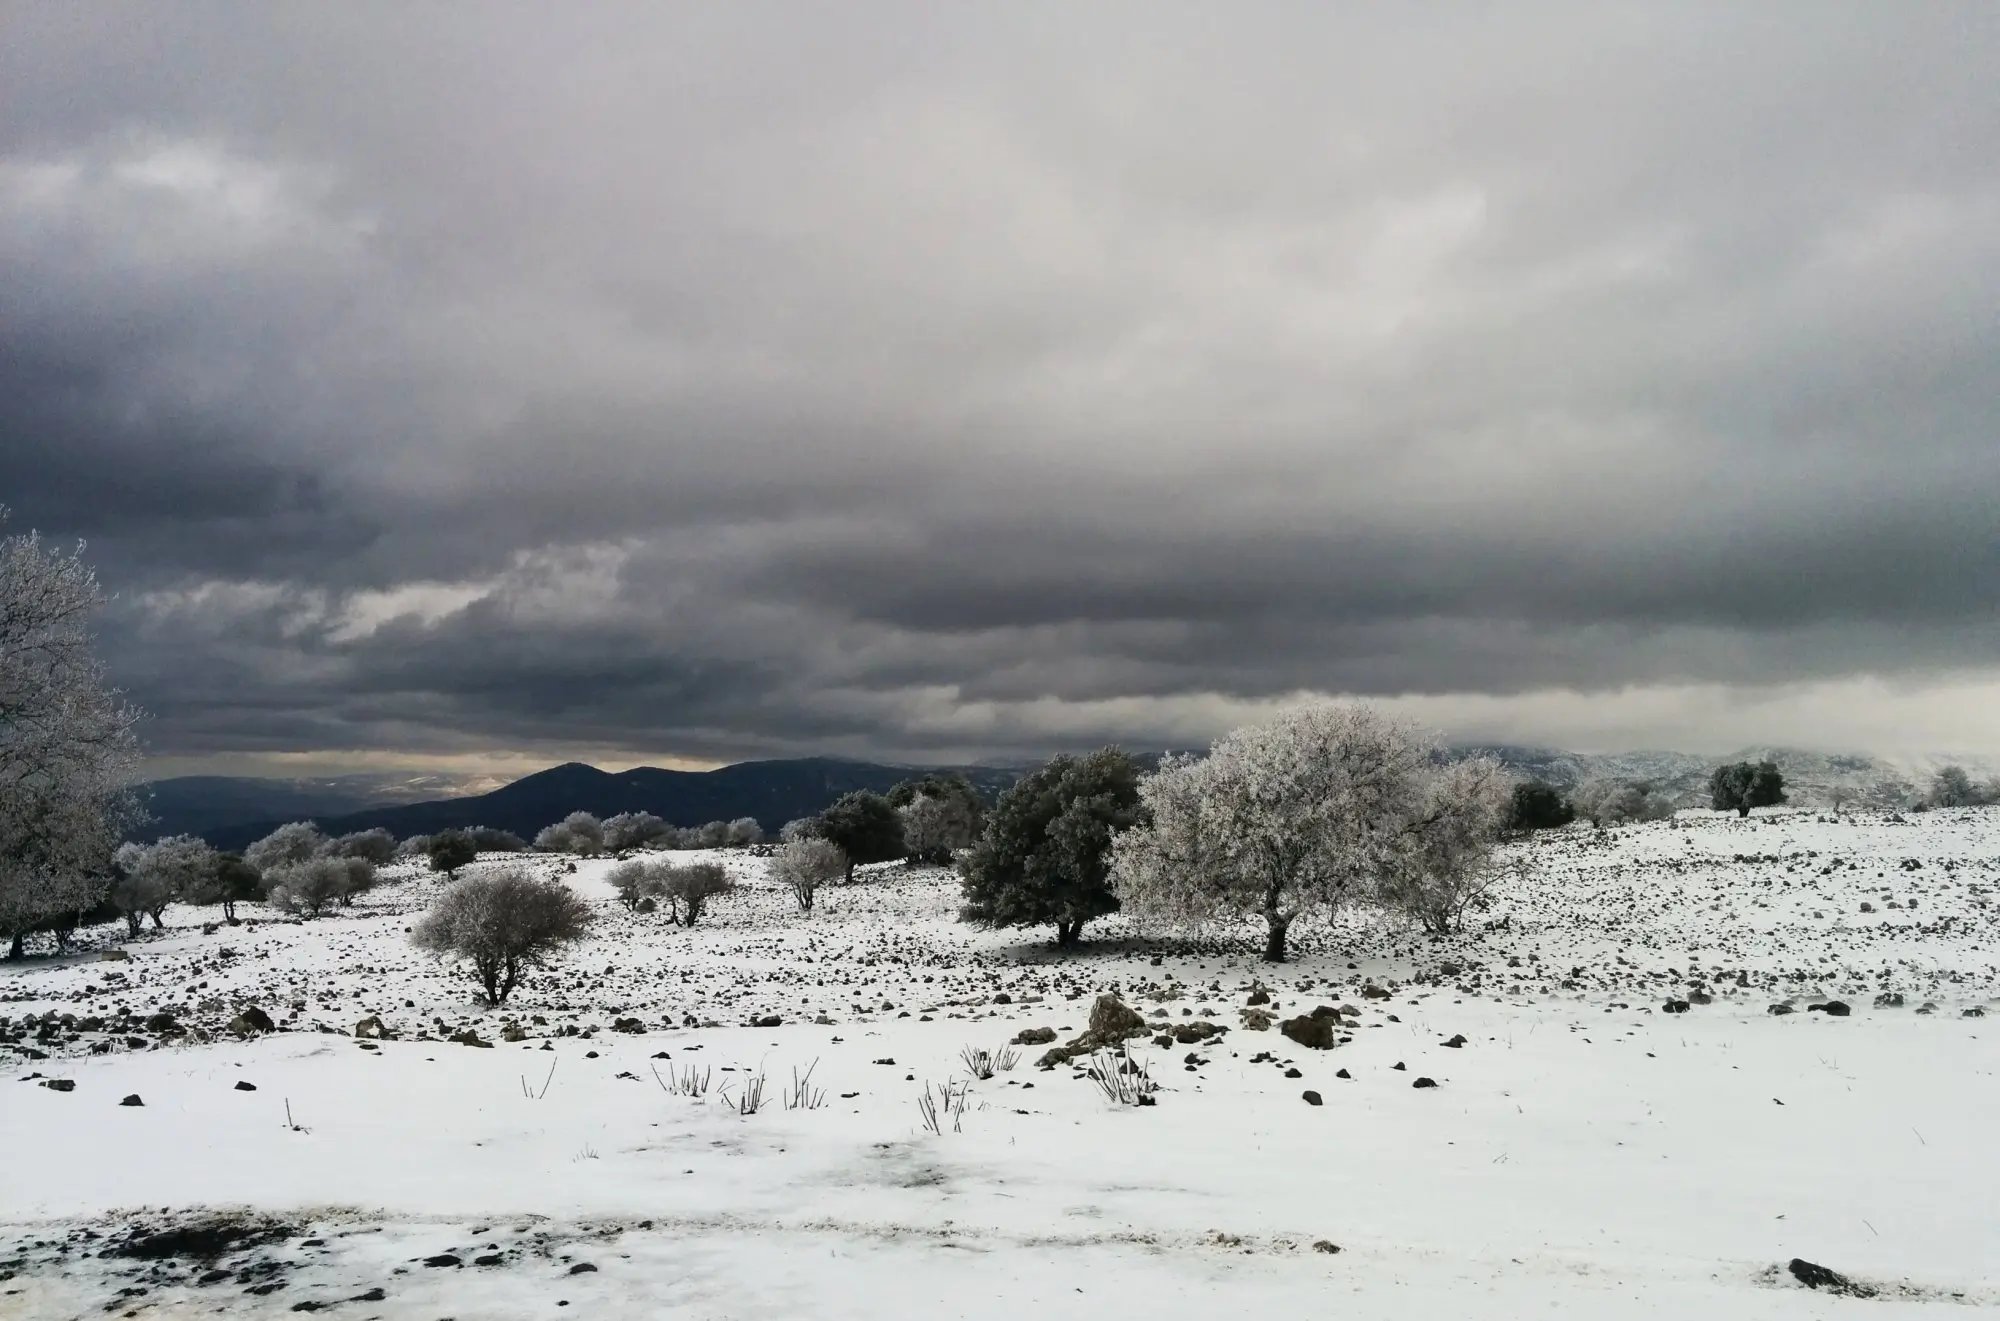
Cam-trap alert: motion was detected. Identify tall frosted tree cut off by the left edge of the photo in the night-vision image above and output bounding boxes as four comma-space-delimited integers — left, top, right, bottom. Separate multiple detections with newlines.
0, 510, 140, 959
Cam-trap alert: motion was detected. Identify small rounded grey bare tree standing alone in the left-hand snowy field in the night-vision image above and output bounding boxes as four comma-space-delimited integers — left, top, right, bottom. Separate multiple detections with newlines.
410, 867, 592, 1009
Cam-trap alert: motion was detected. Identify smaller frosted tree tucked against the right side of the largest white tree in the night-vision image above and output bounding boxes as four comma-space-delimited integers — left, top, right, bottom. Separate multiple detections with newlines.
1376, 757, 1514, 935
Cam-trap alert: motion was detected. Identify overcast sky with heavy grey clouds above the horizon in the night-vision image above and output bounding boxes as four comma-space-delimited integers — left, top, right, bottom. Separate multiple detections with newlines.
0, 0, 2000, 773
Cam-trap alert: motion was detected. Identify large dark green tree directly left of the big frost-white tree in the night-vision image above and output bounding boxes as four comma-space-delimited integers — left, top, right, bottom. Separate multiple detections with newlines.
960, 747, 1140, 947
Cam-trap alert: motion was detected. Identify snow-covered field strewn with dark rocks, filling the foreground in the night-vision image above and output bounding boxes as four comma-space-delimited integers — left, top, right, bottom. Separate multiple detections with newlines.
0, 809, 2000, 1321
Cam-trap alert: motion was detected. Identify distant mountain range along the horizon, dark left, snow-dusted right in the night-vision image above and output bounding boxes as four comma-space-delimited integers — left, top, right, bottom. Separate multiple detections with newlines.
142, 745, 2000, 849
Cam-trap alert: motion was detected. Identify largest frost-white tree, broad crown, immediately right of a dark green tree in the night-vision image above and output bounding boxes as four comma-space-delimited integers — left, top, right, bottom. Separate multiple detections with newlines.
1114, 705, 1436, 963
